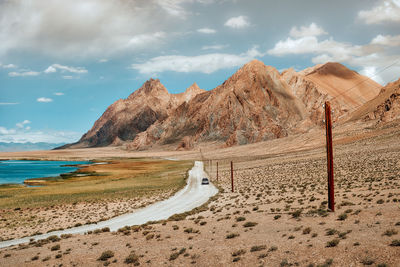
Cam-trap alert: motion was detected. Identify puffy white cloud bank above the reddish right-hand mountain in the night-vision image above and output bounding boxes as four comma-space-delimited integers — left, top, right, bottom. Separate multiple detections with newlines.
268, 24, 400, 84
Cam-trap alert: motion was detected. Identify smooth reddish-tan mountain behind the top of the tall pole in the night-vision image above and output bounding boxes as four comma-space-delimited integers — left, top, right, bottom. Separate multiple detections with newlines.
282, 62, 382, 124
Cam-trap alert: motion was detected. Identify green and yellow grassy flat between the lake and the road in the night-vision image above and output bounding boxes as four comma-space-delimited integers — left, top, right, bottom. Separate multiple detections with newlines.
0, 158, 193, 240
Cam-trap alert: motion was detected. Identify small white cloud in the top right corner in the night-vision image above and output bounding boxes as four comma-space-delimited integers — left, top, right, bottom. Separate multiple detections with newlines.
358, 0, 400, 24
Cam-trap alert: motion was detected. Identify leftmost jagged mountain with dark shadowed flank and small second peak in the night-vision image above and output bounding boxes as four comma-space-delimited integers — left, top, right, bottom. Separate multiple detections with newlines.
62, 79, 204, 148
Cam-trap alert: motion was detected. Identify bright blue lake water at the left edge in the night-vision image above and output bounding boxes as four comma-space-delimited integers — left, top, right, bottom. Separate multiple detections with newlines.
0, 160, 90, 184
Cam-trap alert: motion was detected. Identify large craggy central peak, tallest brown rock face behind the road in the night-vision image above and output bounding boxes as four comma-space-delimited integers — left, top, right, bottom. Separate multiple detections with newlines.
129, 60, 306, 149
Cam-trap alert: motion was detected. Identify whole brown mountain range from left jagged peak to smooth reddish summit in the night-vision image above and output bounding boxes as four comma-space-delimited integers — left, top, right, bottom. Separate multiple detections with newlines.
62, 60, 386, 150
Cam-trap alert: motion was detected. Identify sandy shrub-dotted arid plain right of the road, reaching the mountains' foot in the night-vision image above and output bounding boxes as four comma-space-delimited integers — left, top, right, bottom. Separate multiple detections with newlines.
0, 122, 400, 266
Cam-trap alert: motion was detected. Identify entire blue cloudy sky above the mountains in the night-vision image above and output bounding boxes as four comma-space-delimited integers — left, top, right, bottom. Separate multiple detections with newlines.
0, 0, 400, 143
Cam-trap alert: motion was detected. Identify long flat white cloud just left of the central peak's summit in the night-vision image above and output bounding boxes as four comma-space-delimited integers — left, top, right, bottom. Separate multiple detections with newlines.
131, 47, 264, 74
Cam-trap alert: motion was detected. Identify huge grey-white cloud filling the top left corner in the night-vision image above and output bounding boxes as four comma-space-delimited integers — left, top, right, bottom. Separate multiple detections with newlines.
0, 0, 175, 59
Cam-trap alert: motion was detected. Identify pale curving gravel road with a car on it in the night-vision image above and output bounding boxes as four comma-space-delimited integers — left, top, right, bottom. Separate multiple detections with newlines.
0, 161, 218, 248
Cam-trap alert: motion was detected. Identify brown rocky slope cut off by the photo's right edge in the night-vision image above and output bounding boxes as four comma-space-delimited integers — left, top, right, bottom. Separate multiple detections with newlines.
350, 79, 400, 123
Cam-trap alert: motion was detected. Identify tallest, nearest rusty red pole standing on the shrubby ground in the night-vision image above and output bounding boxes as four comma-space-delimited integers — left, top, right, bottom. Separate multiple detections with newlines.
325, 101, 335, 211
